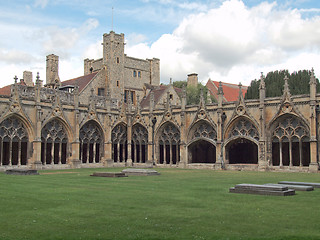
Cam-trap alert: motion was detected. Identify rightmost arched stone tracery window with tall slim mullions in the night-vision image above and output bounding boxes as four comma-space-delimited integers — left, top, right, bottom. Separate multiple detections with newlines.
272, 116, 310, 166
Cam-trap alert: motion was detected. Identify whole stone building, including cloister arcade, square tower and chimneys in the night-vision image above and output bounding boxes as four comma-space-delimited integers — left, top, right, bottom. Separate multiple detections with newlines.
0, 32, 320, 172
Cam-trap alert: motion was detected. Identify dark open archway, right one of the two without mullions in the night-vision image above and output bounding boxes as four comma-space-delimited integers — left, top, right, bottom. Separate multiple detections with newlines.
226, 138, 258, 164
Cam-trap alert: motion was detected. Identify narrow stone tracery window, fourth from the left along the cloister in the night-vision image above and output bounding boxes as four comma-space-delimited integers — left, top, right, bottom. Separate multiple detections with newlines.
111, 124, 128, 162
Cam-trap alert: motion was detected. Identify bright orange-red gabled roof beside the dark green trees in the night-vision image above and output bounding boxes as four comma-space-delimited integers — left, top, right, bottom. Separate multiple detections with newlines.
206, 79, 248, 102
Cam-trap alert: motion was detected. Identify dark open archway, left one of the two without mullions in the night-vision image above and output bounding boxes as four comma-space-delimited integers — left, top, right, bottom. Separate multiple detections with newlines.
188, 139, 216, 163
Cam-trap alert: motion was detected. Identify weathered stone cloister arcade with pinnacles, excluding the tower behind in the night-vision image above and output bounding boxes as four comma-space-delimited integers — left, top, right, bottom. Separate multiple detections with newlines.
0, 71, 320, 172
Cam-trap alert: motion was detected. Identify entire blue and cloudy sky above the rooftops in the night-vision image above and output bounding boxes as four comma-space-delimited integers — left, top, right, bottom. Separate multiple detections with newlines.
0, 0, 320, 87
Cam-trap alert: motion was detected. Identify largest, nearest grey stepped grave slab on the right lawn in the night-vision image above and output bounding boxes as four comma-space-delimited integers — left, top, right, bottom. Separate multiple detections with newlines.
229, 183, 295, 196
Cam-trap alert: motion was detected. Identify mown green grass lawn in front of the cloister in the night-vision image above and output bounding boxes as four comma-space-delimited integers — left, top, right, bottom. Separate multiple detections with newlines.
0, 169, 320, 239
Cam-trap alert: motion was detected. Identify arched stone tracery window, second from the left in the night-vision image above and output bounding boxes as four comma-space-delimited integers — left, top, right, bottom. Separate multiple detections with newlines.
41, 119, 68, 165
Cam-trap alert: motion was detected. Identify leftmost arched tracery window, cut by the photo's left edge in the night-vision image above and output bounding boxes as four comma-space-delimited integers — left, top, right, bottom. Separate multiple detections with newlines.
0, 117, 28, 166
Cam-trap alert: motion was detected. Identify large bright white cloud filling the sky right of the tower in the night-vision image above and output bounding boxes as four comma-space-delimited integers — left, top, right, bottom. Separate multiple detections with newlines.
127, 0, 320, 84
